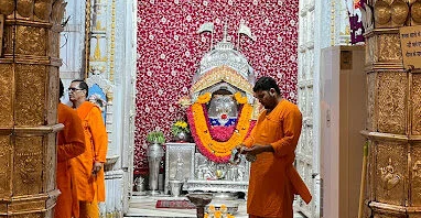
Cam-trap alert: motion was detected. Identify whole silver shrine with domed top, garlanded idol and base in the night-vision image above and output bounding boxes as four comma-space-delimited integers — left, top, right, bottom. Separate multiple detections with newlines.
165, 21, 259, 198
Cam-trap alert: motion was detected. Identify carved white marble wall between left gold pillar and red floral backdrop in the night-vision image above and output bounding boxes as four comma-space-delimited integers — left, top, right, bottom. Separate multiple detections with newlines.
60, 0, 137, 217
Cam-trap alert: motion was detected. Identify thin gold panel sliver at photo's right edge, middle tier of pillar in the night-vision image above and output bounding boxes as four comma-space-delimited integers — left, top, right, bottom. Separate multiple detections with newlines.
411, 74, 421, 135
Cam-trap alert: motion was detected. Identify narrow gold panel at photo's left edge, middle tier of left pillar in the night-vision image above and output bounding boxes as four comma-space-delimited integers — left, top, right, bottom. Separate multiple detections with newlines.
0, 64, 13, 129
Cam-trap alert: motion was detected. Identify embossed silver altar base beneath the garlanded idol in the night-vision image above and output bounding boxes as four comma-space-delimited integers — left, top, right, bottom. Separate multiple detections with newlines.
164, 143, 250, 196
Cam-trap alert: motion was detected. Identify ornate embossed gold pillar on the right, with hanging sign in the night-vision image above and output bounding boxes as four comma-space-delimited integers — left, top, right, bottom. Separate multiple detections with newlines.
364, 0, 421, 218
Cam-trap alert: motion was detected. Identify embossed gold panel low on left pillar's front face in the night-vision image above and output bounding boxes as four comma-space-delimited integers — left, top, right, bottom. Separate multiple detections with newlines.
13, 136, 43, 196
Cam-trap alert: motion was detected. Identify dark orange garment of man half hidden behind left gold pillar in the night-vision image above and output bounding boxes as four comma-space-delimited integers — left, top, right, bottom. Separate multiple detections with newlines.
54, 103, 86, 218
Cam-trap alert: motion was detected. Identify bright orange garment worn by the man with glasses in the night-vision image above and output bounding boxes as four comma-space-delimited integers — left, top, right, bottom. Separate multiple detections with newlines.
73, 101, 108, 205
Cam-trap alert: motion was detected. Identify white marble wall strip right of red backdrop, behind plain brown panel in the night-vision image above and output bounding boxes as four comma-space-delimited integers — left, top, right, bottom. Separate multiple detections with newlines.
296, 0, 349, 217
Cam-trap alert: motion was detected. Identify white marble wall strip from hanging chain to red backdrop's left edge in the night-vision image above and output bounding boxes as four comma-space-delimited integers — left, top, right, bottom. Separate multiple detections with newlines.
85, 0, 136, 218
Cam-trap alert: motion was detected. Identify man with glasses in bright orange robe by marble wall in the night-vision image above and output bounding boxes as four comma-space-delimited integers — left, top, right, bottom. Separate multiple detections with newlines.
69, 80, 108, 218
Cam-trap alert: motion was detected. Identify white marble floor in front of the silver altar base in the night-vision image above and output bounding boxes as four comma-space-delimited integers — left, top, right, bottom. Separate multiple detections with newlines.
125, 196, 303, 218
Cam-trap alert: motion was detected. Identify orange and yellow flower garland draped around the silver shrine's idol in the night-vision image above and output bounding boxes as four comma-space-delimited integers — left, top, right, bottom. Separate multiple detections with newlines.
187, 93, 253, 163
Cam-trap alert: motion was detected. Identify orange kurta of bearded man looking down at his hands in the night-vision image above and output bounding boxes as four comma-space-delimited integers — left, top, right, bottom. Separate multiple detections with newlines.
244, 99, 312, 218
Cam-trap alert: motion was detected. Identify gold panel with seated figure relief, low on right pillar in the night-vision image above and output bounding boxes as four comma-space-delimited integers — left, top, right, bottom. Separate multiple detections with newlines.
375, 142, 408, 206
